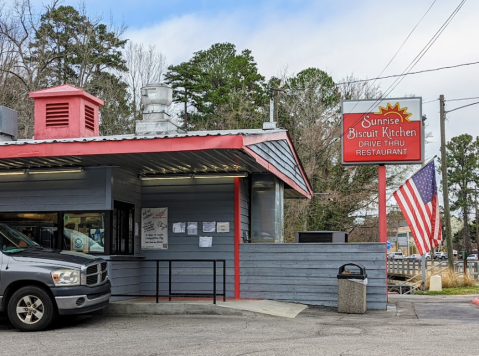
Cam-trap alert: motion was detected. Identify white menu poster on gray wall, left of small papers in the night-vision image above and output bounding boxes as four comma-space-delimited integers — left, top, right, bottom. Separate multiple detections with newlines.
141, 208, 168, 250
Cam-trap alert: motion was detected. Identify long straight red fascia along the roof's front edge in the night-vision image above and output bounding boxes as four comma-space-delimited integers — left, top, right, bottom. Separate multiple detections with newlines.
0, 135, 243, 159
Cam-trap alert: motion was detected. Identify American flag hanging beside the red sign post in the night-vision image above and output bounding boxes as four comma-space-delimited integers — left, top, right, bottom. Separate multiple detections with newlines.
393, 160, 442, 255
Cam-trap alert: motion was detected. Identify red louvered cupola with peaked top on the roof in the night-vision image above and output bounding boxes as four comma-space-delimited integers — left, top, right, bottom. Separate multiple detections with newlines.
30, 84, 103, 140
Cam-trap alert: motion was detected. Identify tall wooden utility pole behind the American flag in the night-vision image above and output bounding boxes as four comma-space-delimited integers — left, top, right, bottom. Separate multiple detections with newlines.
439, 94, 454, 269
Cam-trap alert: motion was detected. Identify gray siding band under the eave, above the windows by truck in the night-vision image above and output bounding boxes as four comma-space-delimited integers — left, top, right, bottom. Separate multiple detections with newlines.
0, 168, 111, 212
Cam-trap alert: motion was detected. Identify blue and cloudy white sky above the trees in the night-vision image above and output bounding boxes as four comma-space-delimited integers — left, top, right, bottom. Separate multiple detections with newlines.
18, 0, 479, 178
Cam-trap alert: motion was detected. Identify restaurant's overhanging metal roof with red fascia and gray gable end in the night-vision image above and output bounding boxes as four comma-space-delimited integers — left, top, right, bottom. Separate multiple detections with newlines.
0, 129, 311, 197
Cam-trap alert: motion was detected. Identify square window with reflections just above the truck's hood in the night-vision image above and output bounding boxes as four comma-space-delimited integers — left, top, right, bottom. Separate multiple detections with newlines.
62, 212, 106, 253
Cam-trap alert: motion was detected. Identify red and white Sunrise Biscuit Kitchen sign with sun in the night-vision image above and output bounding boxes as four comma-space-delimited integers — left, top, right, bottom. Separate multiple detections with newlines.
341, 98, 424, 165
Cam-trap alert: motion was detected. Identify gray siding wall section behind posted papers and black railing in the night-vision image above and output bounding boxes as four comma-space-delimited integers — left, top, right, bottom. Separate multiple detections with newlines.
141, 178, 234, 297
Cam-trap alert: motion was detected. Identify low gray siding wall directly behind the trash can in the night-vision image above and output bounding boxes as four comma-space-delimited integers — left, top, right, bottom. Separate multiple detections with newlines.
240, 243, 387, 310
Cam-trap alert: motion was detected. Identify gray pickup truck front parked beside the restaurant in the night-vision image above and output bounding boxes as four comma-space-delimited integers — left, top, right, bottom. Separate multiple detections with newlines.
0, 223, 111, 331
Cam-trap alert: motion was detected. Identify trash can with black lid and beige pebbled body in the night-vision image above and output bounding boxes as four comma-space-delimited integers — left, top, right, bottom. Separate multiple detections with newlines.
338, 263, 368, 314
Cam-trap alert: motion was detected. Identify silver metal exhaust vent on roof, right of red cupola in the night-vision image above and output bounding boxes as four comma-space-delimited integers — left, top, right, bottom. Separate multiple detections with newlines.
135, 83, 178, 135
